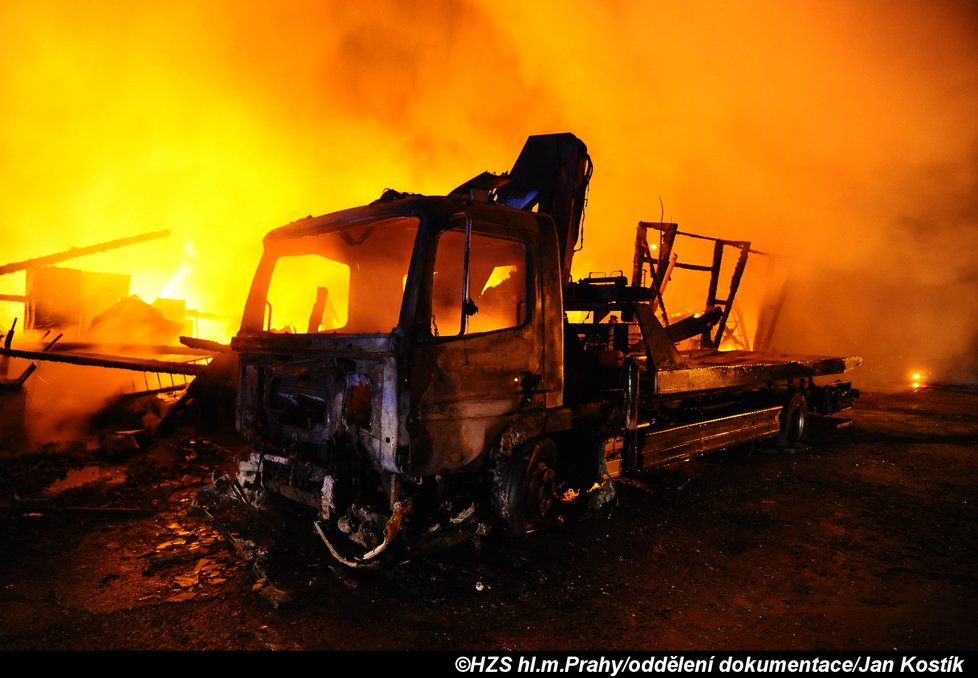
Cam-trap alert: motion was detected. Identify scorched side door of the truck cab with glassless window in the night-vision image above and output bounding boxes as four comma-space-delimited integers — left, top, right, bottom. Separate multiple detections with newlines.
411, 213, 544, 475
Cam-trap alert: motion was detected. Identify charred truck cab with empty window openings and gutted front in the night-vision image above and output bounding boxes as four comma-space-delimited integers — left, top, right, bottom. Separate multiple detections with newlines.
234, 194, 569, 562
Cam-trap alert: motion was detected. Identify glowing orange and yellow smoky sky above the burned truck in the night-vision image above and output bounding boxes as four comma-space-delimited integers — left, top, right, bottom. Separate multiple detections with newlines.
0, 0, 978, 388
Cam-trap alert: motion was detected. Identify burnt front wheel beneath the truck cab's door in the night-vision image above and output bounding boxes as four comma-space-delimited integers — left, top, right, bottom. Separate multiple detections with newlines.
499, 438, 557, 536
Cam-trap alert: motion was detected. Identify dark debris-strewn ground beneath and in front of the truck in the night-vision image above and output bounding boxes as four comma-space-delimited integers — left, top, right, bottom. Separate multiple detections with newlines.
0, 388, 978, 651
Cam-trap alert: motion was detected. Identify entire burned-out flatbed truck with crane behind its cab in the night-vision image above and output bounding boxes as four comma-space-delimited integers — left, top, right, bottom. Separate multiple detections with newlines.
232, 133, 860, 567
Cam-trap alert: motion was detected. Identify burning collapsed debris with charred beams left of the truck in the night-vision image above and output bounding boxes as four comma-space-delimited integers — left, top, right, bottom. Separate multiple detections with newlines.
0, 231, 235, 455
